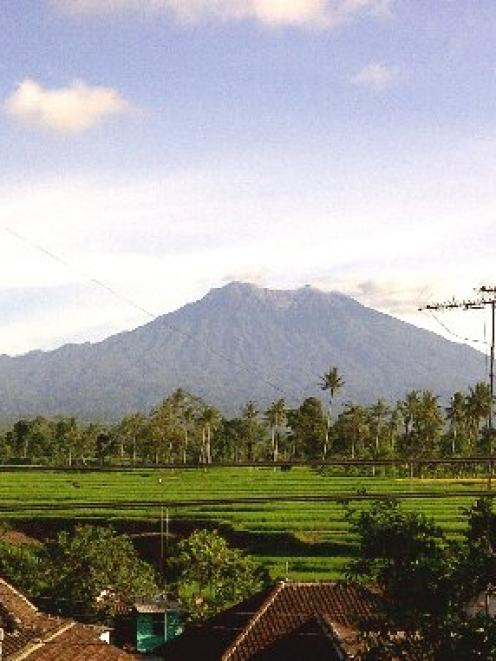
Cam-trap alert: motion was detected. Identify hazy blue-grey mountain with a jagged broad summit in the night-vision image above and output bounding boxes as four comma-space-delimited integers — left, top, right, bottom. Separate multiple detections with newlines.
0, 282, 484, 419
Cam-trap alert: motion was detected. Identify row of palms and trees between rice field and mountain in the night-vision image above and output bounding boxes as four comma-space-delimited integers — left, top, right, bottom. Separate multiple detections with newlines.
0, 367, 493, 467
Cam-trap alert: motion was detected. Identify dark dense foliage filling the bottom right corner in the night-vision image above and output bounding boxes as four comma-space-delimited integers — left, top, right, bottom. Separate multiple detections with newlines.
348, 499, 496, 661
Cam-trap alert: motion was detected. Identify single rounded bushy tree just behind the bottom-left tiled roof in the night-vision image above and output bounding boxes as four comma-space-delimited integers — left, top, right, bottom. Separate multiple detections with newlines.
46, 525, 157, 621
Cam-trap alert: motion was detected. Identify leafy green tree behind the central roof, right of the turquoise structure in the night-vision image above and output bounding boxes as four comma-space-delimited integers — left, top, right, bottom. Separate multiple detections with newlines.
173, 530, 267, 621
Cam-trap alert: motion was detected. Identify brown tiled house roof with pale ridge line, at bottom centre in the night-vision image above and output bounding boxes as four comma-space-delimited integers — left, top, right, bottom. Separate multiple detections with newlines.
159, 581, 380, 661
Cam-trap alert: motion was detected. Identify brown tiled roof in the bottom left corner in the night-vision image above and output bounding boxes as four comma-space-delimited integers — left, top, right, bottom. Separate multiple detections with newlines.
0, 579, 138, 661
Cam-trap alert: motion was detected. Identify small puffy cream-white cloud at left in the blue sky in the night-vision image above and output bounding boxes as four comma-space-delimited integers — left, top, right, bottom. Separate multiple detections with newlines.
4, 79, 129, 133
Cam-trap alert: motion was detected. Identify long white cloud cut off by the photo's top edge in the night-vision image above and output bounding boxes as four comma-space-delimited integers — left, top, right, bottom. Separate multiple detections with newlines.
50, 0, 395, 28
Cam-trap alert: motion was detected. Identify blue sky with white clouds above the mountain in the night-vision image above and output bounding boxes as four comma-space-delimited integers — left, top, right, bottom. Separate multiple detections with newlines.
0, 0, 496, 354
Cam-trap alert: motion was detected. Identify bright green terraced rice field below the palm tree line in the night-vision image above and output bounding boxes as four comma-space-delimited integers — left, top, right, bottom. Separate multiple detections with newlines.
0, 467, 491, 579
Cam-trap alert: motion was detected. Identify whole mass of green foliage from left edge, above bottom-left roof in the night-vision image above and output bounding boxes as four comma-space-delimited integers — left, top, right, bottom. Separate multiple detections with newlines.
0, 525, 158, 622
